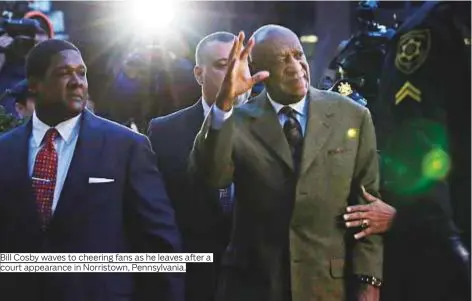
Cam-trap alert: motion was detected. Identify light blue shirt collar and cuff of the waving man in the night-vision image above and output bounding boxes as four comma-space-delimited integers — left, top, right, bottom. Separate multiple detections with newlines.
211, 93, 308, 136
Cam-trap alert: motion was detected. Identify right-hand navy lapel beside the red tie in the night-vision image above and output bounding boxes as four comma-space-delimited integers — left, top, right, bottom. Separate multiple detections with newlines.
51, 110, 105, 228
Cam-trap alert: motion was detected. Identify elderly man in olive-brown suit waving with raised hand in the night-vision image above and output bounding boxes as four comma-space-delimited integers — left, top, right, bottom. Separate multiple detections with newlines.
190, 25, 383, 301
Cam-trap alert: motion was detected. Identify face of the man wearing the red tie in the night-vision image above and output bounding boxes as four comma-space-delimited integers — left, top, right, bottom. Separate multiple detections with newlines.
35, 50, 88, 116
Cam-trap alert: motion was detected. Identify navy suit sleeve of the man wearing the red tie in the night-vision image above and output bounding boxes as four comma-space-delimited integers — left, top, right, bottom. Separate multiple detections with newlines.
127, 135, 184, 301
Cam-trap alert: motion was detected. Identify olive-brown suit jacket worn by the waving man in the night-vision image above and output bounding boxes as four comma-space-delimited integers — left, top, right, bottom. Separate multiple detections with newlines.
190, 88, 383, 301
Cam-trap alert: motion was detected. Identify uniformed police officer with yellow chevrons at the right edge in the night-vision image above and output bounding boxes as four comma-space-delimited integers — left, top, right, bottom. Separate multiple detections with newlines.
373, 2, 471, 301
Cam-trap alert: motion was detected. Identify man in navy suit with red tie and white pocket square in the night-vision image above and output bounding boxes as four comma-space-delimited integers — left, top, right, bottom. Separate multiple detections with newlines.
0, 40, 183, 301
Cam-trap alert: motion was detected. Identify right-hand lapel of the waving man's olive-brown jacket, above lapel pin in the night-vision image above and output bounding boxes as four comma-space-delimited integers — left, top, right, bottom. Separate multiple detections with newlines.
300, 88, 334, 174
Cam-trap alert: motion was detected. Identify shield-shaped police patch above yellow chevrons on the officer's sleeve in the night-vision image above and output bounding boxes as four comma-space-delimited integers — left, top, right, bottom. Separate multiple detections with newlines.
395, 29, 431, 74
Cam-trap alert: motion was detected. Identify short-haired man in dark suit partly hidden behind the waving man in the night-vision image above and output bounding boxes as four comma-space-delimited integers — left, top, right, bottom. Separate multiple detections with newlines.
149, 32, 251, 301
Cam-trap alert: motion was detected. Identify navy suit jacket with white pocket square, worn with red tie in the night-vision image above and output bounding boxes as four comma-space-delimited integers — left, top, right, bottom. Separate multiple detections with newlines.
0, 111, 183, 301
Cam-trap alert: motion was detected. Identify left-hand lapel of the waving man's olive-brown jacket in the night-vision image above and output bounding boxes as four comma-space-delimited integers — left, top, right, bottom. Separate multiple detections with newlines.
246, 90, 294, 170
